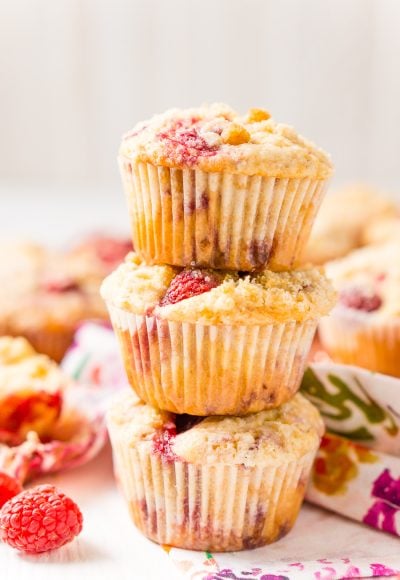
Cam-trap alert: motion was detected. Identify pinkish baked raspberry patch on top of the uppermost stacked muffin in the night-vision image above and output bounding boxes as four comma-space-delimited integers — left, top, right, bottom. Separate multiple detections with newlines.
158, 119, 218, 165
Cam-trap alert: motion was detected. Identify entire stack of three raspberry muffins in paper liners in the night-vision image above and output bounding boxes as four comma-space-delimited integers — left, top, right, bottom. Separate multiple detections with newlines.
102, 105, 335, 550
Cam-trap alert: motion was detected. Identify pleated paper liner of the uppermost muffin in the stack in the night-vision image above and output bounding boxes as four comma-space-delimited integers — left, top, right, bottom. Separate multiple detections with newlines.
119, 157, 326, 271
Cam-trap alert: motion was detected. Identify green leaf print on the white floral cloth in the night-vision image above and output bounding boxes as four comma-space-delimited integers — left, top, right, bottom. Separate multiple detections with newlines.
301, 368, 399, 441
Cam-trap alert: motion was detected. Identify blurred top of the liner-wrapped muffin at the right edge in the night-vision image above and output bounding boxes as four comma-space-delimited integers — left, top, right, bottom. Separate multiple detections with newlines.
327, 239, 400, 323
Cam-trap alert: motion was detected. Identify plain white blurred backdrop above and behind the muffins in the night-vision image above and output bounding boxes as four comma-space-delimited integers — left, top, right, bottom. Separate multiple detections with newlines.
0, 0, 400, 239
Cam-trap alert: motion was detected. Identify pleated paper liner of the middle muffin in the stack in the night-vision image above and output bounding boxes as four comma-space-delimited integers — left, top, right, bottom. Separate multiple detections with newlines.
109, 306, 317, 415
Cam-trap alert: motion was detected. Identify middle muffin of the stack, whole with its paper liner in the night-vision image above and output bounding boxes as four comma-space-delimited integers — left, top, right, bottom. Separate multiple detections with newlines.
101, 253, 335, 415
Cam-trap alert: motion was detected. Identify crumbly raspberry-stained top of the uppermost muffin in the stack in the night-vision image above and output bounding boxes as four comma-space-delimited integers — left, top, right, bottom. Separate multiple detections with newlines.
120, 103, 332, 179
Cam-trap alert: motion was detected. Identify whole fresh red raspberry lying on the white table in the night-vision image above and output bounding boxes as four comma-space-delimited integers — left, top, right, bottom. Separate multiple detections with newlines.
0, 485, 83, 554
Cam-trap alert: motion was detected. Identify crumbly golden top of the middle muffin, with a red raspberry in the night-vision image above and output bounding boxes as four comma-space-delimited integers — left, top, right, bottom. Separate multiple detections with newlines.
101, 252, 336, 324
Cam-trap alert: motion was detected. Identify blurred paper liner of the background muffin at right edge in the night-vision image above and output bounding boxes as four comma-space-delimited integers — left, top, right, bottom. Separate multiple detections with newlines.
319, 309, 400, 377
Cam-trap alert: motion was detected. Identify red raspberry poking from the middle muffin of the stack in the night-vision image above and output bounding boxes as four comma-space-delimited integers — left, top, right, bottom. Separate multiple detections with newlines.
160, 270, 220, 306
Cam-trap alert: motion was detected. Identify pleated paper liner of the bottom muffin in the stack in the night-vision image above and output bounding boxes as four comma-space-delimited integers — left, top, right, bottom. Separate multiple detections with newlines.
109, 416, 316, 551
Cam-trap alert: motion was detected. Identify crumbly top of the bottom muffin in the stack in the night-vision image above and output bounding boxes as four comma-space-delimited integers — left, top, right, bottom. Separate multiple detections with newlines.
108, 390, 324, 466
